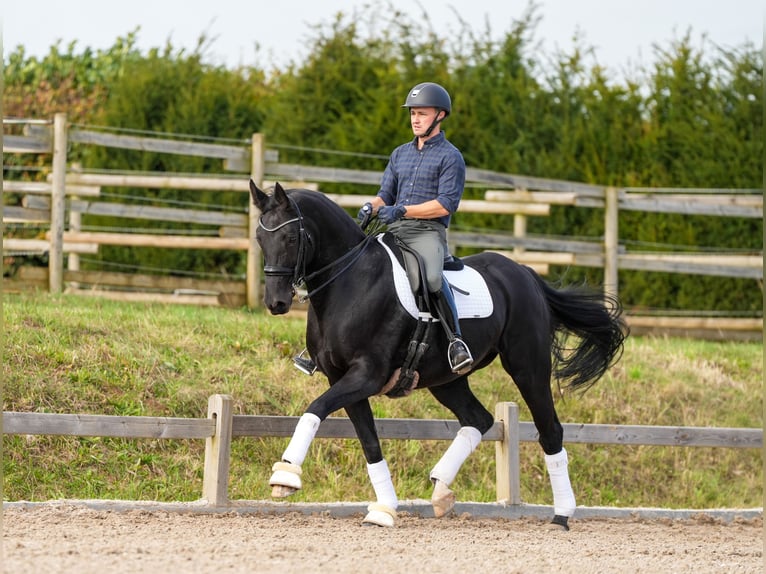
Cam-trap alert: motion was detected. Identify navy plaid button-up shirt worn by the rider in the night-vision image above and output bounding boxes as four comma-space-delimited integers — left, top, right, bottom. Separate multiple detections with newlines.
378, 132, 465, 227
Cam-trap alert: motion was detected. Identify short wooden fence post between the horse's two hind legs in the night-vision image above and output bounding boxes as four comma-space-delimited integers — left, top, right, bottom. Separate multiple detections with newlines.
495, 402, 521, 504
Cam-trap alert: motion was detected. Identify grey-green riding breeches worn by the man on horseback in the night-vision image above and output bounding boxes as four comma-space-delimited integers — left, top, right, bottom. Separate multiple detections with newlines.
388, 219, 448, 293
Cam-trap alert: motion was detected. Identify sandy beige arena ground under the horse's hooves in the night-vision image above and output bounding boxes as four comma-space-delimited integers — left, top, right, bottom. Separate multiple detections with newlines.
2, 504, 764, 574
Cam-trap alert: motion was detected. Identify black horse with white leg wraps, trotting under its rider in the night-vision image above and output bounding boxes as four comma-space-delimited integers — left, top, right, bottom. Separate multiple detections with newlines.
250, 181, 627, 528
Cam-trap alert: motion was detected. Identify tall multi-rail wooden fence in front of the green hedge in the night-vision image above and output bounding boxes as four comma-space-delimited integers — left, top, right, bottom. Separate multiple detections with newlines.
3, 114, 763, 338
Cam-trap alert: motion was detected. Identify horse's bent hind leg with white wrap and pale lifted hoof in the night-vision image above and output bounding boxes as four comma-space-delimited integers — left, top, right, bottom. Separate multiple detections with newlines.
429, 377, 494, 518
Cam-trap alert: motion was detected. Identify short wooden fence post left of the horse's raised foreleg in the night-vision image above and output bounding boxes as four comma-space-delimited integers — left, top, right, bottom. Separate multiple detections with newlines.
202, 395, 232, 506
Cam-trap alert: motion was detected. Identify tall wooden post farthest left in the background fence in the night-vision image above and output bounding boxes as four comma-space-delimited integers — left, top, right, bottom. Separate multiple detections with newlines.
48, 113, 67, 293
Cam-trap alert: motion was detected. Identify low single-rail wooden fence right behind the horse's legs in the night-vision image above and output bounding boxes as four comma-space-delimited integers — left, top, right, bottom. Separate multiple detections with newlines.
2, 395, 763, 506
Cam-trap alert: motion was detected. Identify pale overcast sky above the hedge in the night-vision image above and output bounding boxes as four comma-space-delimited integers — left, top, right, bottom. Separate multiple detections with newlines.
2, 0, 766, 76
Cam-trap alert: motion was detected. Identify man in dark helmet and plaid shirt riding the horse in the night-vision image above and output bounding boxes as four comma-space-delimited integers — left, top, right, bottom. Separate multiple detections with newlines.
359, 82, 473, 373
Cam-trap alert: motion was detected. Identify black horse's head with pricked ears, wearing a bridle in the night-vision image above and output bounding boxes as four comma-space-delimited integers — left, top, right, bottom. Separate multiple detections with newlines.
250, 180, 310, 315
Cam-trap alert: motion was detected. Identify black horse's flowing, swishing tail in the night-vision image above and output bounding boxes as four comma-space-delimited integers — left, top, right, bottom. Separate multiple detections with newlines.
537, 277, 629, 390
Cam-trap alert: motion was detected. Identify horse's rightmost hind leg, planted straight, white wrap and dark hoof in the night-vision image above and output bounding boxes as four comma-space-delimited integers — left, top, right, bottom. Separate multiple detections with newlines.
501, 344, 577, 530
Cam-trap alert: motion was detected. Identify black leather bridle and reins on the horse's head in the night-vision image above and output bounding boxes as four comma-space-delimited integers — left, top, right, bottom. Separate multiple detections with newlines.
258, 196, 372, 302
